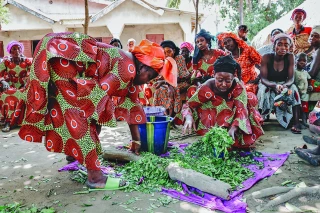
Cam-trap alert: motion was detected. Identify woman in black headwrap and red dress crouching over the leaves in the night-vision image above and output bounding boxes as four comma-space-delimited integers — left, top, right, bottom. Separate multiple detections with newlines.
175, 55, 264, 148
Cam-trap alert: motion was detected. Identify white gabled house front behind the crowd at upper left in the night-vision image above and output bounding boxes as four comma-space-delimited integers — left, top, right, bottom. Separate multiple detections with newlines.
0, 0, 193, 54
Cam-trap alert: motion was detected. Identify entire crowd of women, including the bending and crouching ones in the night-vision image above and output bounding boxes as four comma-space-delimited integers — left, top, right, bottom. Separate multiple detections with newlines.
0, 9, 320, 189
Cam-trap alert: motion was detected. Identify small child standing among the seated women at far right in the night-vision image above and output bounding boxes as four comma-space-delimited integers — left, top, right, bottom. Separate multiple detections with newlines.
294, 53, 311, 127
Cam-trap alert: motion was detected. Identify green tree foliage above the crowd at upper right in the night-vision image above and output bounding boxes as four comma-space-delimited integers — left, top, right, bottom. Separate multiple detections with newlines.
220, 0, 305, 39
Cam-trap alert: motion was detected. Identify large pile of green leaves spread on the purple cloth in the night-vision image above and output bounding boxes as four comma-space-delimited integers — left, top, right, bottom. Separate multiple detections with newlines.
117, 127, 257, 193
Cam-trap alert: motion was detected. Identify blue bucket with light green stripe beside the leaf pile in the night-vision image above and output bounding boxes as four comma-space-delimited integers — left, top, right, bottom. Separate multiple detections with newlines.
139, 116, 173, 155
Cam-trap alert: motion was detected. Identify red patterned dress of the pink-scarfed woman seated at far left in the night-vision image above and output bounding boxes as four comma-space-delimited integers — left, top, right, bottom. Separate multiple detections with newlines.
0, 57, 32, 126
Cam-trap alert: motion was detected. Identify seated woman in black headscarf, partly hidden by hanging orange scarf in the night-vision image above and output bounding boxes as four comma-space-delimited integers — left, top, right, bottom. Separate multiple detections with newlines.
152, 40, 191, 116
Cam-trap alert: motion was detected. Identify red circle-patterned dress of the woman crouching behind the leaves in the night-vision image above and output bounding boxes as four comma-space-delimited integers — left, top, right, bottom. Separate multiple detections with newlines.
175, 80, 264, 148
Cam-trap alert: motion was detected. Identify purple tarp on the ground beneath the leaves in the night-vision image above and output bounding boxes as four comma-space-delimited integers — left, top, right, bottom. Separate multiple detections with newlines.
59, 142, 290, 213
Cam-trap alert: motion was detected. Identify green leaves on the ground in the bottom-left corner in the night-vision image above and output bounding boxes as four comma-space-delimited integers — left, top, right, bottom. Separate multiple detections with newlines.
0, 202, 56, 213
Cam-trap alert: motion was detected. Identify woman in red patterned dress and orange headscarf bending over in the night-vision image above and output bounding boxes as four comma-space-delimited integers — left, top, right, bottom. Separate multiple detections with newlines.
19, 33, 176, 189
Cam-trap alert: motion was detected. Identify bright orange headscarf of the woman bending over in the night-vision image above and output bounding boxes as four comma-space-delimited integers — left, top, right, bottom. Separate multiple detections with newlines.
131, 39, 178, 87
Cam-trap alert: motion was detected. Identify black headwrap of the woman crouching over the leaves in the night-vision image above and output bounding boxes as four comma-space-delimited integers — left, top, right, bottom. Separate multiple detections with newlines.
213, 55, 241, 75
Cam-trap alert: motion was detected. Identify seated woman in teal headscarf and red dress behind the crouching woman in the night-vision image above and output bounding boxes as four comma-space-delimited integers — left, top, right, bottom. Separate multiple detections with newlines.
188, 29, 226, 98
